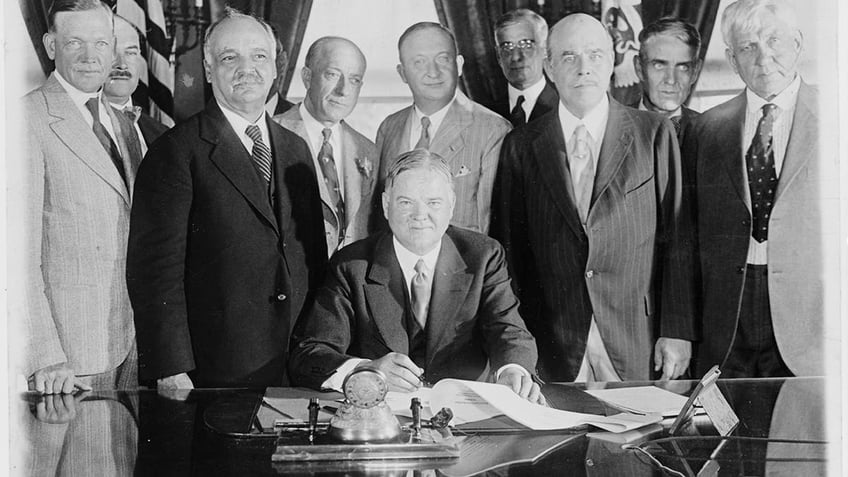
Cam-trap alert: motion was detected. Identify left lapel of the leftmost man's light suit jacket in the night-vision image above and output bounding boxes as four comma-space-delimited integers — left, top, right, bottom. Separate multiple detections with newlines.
42, 75, 130, 205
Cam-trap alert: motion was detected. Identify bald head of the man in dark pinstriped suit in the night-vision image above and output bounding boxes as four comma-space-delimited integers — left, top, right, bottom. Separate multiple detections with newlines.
545, 13, 615, 118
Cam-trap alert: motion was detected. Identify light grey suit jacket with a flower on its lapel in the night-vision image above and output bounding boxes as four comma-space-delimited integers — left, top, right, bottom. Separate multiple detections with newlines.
274, 104, 379, 256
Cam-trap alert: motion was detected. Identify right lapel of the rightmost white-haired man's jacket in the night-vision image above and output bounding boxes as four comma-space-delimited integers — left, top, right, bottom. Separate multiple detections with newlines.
774, 83, 818, 202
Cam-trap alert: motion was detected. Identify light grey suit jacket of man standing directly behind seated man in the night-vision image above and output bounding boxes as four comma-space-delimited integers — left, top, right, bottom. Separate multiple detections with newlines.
377, 91, 512, 233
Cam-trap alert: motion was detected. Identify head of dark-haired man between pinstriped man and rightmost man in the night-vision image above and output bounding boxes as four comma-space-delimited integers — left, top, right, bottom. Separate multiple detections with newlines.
633, 18, 703, 136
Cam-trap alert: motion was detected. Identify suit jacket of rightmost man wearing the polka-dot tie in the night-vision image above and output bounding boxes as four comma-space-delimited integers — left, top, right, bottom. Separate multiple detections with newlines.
683, 83, 838, 375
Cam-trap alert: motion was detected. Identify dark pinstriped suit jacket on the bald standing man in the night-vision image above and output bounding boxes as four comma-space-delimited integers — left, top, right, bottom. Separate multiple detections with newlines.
492, 96, 695, 381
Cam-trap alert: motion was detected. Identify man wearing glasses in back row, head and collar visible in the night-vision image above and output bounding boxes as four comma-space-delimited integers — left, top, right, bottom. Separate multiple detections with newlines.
495, 8, 559, 127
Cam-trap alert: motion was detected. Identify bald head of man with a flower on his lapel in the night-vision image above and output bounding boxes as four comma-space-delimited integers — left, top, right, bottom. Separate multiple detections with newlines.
301, 36, 366, 127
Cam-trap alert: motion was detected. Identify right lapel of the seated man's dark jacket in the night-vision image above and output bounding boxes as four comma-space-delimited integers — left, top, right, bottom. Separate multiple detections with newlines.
425, 234, 474, 369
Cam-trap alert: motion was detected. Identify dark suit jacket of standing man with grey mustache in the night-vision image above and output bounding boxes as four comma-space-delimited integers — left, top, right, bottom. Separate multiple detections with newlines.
127, 100, 327, 387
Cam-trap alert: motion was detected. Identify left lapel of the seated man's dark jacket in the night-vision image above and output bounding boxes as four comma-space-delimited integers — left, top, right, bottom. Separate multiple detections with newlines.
364, 233, 409, 354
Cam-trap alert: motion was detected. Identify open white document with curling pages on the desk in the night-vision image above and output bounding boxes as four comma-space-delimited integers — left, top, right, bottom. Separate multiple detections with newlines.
387, 379, 662, 432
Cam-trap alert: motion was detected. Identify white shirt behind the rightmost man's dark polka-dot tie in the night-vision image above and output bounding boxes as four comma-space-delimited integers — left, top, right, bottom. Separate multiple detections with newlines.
741, 75, 801, 265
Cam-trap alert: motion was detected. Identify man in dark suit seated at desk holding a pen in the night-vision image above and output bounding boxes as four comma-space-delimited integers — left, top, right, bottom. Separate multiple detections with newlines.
289, 149, 542, 402
